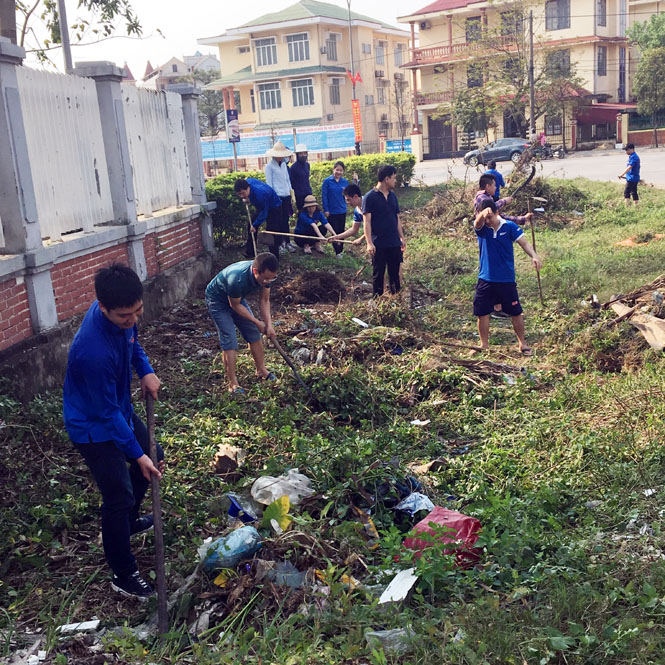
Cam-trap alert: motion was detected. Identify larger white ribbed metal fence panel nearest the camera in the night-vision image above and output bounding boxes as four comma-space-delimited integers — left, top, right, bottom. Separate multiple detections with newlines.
16, 67, 113, 240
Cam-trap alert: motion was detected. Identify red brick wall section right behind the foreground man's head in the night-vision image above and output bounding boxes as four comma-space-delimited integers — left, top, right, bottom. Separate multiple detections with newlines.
51, 243, 129, 321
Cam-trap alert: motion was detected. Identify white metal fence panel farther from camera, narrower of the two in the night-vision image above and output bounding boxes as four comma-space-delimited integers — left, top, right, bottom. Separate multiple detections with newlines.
122, 84, 191, 216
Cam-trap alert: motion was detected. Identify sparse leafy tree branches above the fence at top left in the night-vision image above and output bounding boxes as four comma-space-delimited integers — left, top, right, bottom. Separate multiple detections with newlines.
15, 0, 142, 60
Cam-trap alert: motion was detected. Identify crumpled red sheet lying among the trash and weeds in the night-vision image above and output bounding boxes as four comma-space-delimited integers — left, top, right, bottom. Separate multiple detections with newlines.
404, 506, 481, 568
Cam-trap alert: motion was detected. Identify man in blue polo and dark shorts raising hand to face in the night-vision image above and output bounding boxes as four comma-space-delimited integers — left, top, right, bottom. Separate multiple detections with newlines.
473, 201, 542, 355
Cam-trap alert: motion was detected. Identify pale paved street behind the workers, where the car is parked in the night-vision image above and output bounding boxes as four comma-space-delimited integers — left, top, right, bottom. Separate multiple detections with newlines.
414, 148, 665, 188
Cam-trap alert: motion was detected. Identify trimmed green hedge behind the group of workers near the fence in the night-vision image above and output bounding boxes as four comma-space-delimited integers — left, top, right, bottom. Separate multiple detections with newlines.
206, 152, 416, 247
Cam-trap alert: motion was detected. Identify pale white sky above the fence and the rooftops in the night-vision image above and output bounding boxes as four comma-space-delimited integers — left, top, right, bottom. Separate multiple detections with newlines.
26, 0, 410, 79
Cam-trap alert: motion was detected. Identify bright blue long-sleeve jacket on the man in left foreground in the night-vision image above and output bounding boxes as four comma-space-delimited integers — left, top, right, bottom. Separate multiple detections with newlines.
63, 301, 153, 459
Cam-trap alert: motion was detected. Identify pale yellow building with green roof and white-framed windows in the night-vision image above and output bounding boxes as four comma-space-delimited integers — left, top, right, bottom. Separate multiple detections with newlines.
198, 0, 413, 158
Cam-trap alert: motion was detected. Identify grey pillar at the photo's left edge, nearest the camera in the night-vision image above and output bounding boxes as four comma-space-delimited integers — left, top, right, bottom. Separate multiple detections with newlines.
0, 37, 42, 254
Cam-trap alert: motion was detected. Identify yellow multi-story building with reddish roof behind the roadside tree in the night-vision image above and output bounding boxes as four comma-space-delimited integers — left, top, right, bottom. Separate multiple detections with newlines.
398, 0, 665, 157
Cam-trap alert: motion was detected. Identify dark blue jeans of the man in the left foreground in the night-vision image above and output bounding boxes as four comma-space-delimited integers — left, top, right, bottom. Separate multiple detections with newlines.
74, 413, 164, 577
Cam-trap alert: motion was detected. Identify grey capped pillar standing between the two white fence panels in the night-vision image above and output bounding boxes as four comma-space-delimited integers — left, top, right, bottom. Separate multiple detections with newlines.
74, 61, 137, 224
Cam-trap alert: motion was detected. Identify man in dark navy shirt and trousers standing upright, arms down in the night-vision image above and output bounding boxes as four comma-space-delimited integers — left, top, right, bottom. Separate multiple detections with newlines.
362, 164, 406, 296
